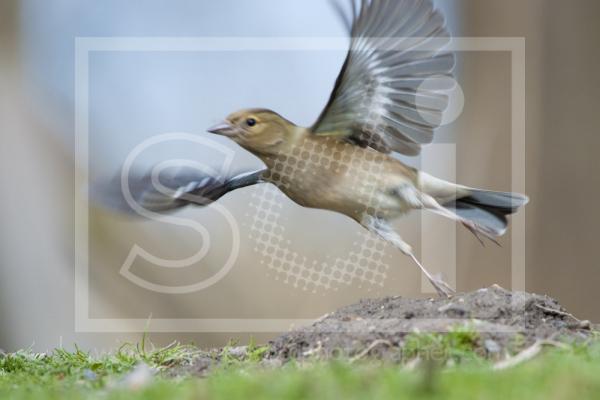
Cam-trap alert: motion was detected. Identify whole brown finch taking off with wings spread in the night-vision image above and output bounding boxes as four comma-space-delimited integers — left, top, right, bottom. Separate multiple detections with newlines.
101, 0, 529, 297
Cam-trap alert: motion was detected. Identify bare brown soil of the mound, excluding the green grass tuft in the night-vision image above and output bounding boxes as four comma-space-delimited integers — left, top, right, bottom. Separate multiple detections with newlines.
269, 286, 591, 361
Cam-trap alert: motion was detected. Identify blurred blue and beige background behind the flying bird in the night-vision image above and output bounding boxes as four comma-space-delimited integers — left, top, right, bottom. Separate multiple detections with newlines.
0, 0, 600, 350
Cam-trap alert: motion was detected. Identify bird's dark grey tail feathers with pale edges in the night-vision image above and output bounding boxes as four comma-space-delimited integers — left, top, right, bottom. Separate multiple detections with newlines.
443, 189, 529, 240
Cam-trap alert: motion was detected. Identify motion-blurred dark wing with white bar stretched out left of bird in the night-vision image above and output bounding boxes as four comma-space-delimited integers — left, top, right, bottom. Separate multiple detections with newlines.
91, 168, 264, 214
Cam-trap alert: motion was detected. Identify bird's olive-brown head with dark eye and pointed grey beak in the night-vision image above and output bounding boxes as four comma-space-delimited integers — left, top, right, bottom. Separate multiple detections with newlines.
208, 109, 297, 155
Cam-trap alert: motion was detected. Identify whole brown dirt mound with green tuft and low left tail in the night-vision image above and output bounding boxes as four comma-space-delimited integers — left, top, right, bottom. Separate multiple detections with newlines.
168, 286, 598, 376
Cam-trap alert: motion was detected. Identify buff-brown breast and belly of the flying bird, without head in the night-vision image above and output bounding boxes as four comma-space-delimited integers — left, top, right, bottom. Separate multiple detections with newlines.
264, 139, 411, 221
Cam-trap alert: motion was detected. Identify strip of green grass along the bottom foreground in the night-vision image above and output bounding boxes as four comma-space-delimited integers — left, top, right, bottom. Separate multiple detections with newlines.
0, 329, 600, 400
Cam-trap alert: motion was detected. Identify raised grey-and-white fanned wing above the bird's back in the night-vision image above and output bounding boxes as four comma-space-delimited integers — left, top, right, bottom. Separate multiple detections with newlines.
312, 0, 455, 155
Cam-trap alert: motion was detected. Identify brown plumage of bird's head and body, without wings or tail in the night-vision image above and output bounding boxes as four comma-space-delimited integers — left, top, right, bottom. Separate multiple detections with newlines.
215, 110, 418, 222
